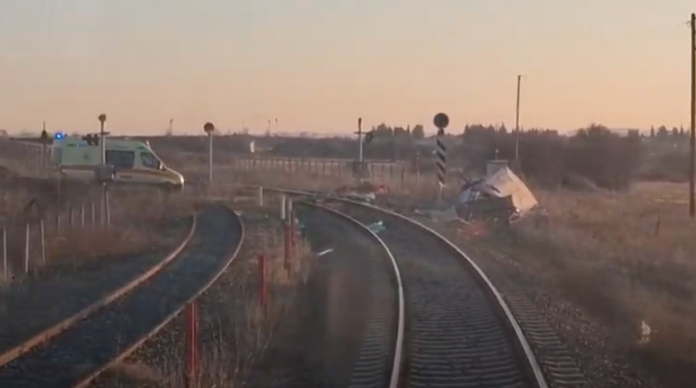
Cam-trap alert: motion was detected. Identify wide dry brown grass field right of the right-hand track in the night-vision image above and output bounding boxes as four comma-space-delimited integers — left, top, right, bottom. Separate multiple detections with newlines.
215, 163, 696, 382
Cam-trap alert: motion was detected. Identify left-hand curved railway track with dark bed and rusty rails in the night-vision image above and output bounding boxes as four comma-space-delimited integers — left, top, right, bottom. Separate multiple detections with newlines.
0, 205, 244, 388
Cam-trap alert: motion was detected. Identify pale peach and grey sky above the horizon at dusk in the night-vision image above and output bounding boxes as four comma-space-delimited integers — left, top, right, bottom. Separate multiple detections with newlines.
0, 0, 696, 134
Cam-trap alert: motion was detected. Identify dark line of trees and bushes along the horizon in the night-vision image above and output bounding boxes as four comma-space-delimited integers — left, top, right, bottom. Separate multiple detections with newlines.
147, 124, 688, 190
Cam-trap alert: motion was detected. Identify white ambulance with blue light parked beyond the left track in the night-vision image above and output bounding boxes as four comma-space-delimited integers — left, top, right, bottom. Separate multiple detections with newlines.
51, 135, 184, 189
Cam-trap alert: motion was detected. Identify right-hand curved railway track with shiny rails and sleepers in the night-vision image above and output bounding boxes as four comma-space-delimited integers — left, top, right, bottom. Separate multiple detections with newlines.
256, 188, 548, 388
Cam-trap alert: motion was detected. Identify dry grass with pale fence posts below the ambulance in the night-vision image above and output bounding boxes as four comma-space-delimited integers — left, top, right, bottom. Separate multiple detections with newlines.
0, 182, 193, 280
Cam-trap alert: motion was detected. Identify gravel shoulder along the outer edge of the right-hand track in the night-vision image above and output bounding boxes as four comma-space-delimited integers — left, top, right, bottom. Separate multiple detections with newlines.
407, 214, 678, 388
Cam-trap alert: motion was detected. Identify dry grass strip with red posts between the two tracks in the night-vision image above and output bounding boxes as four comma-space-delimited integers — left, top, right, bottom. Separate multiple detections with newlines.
109, 198, 312, 388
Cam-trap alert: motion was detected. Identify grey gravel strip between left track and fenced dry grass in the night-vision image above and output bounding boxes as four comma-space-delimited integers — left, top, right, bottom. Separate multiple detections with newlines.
0, 218, 191, 358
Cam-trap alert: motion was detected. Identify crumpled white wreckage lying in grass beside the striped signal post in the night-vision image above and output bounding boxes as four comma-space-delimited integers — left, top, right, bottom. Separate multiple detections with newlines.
458, 167, 538, 215
